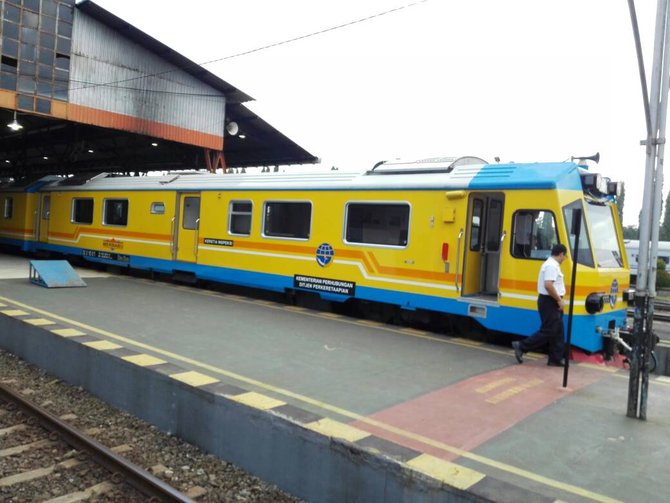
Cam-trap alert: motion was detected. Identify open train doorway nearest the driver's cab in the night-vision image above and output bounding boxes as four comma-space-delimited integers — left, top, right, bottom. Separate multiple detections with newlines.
462, 193, 504, 296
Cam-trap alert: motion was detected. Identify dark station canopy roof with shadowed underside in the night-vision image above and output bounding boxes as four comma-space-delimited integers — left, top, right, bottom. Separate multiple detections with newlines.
0, 1, 318, 179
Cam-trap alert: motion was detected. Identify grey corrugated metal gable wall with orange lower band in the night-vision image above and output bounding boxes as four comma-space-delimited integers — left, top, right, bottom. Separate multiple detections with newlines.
68, 10, 226, 144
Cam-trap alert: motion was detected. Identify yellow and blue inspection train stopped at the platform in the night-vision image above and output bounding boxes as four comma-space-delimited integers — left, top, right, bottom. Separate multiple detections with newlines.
0, 157, 630, 352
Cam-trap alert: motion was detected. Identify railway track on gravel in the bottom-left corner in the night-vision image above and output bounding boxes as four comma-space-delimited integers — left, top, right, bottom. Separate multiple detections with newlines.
0, 384, 193, 503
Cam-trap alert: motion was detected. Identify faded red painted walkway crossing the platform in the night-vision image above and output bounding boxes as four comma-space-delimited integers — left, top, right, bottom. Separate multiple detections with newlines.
353, 360, 607, 461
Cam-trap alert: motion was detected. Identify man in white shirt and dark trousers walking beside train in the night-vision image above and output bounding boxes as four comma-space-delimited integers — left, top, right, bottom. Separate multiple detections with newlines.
512, 244, 568, 367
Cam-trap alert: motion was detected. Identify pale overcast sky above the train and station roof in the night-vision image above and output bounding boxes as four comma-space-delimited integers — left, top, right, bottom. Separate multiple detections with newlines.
94, 0, 667, 225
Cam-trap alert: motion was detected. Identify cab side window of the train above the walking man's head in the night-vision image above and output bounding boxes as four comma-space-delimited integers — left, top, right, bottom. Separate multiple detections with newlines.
512, 210, 558, 260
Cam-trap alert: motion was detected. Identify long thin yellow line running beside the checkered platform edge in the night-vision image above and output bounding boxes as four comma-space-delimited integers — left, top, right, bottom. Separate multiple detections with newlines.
0, 297, 621, 503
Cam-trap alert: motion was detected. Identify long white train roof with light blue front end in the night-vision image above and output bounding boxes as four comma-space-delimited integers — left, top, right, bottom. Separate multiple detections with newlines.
35, 157, 624, 196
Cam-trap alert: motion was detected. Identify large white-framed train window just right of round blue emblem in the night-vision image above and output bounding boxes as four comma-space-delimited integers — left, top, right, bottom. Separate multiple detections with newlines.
344, 201, 412, 248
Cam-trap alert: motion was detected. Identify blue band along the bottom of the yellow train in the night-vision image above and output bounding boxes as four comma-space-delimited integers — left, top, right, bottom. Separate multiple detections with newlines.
30, 243, 626, 352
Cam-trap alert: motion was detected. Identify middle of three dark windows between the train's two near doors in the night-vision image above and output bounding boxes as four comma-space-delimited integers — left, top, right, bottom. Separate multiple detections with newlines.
263, 201, 312, 239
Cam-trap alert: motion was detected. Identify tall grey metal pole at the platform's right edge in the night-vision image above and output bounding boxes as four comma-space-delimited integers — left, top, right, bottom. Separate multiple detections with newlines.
626, 0, 670, 419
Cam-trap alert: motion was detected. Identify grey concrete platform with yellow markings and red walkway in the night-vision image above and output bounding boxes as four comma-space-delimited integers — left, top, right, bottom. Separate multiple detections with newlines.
0, 256, 670, 502
